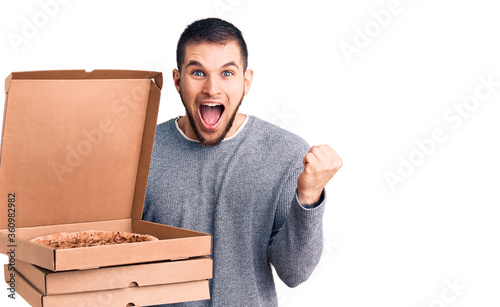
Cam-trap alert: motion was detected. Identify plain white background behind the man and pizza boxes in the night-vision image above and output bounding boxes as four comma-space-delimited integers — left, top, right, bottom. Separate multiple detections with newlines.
0, 0, 500, 307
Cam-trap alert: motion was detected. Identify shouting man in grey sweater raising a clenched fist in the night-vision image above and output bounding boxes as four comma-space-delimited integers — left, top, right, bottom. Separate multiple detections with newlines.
144, 18, 342, 307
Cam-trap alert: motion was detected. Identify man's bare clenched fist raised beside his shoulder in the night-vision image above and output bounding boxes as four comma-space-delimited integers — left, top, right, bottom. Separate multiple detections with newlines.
297, 145, 342, 205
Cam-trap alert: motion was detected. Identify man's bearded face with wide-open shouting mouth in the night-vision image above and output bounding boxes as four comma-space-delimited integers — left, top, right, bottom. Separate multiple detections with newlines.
173, 42, 253, 146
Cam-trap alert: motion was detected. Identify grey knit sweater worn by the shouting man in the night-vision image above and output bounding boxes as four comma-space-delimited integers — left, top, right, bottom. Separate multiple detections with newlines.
143, 116, 325, 307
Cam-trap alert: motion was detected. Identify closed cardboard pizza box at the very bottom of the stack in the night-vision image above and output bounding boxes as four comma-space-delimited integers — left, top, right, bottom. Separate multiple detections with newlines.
4, 271, 210, 307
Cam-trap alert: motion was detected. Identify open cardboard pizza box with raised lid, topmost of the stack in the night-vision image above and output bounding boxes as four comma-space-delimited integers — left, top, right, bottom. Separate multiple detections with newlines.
0, 70, 212, 271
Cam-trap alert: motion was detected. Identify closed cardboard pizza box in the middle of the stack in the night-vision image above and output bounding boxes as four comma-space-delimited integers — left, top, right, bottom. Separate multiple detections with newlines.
4, 256, 212, 295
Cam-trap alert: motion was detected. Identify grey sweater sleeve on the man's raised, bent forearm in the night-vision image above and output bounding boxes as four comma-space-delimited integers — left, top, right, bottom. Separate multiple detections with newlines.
268, 161, 326, 287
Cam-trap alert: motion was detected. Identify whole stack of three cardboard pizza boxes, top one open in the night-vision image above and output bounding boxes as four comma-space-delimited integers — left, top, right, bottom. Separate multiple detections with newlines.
0, 70, 212, 307
